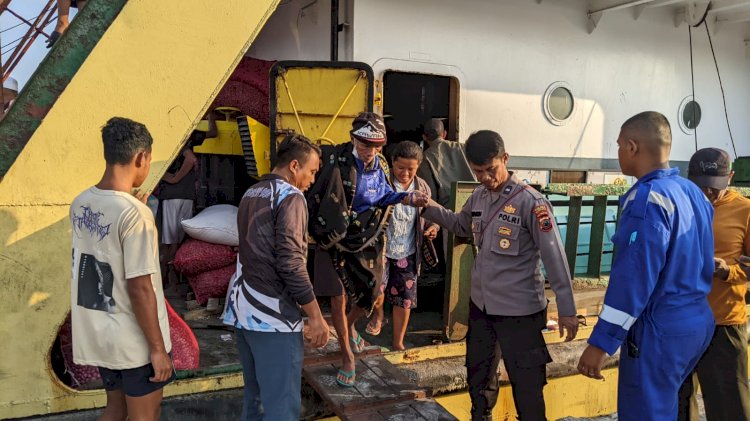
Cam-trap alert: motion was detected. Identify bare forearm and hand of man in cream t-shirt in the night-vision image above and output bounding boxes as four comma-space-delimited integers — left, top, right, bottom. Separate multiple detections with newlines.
127, 275, 173, 382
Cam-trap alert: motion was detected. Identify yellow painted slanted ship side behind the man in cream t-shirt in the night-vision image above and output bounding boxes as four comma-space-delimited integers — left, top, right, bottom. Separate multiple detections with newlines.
0, 0, 278, 418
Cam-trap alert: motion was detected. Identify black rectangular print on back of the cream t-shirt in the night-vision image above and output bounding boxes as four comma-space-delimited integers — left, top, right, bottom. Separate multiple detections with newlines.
78, 253, 115, 313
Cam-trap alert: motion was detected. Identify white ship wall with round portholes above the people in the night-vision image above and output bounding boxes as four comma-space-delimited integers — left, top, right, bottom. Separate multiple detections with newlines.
249, 0, 750, 169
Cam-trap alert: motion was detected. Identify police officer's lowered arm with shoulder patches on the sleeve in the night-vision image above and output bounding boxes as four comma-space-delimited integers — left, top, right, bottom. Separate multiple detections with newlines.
526, 198, 578, 341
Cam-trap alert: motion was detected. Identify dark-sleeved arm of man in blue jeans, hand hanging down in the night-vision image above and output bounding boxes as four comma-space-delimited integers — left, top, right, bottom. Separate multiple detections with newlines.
274, 193, 329, 348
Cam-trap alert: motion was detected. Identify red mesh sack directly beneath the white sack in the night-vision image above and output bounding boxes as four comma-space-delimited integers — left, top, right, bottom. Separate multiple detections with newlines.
172, 238, 237, 276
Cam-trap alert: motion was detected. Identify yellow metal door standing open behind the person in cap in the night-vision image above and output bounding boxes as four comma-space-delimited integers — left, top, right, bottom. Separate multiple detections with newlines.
270, 61, 373, 164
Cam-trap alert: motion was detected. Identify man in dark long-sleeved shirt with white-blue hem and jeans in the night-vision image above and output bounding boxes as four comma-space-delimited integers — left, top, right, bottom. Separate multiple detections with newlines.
224, 135, 329, 421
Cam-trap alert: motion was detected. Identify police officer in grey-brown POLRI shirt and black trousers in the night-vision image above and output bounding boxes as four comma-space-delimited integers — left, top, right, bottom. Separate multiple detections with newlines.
423, 130, 578, 420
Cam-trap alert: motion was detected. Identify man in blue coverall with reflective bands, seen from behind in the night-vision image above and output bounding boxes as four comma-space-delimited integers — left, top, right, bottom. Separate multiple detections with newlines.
578, 111, 714, 421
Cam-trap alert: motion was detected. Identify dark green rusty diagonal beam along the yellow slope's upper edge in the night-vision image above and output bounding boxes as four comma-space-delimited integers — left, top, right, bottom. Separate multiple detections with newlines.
0, 0, 127, 177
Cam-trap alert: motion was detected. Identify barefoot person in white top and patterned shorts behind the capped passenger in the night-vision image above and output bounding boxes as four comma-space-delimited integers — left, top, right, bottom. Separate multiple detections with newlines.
367, 141, 439, 350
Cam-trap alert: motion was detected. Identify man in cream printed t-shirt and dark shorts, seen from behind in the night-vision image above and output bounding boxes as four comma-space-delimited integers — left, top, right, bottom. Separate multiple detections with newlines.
70, 117, 174, 420
